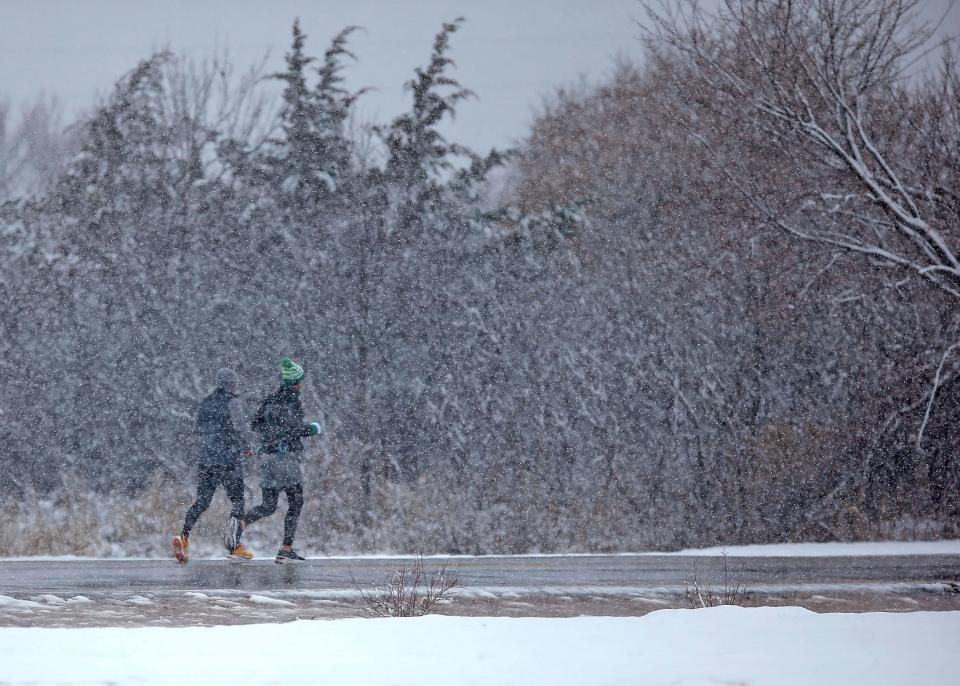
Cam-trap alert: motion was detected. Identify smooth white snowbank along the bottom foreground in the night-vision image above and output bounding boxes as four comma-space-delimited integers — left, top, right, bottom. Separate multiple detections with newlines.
0, 607, 960, 686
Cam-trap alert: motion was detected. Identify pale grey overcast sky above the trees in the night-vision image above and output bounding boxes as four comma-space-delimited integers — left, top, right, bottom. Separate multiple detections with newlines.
0, 0, 960, 150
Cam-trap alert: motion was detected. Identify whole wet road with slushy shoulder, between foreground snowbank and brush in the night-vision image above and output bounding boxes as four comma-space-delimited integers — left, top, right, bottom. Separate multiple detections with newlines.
0, 541, 960, 627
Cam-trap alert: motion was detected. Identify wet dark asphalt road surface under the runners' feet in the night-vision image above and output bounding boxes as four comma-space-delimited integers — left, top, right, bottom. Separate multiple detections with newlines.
0, 555, 960, 596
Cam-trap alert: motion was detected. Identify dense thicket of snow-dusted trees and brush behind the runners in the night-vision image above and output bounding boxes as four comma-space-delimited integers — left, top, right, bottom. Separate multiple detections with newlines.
0, 12, 957, 552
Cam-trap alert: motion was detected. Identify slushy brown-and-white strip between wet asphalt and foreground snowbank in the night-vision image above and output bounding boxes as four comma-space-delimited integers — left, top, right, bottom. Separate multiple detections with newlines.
0, 583, 960, 628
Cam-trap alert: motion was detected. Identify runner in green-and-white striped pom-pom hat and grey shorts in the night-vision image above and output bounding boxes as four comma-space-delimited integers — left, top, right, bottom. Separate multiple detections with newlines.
243, 357, 320, 563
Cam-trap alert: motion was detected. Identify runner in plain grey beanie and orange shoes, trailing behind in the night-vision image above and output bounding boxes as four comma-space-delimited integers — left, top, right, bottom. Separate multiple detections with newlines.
173, 369, 253, 562
